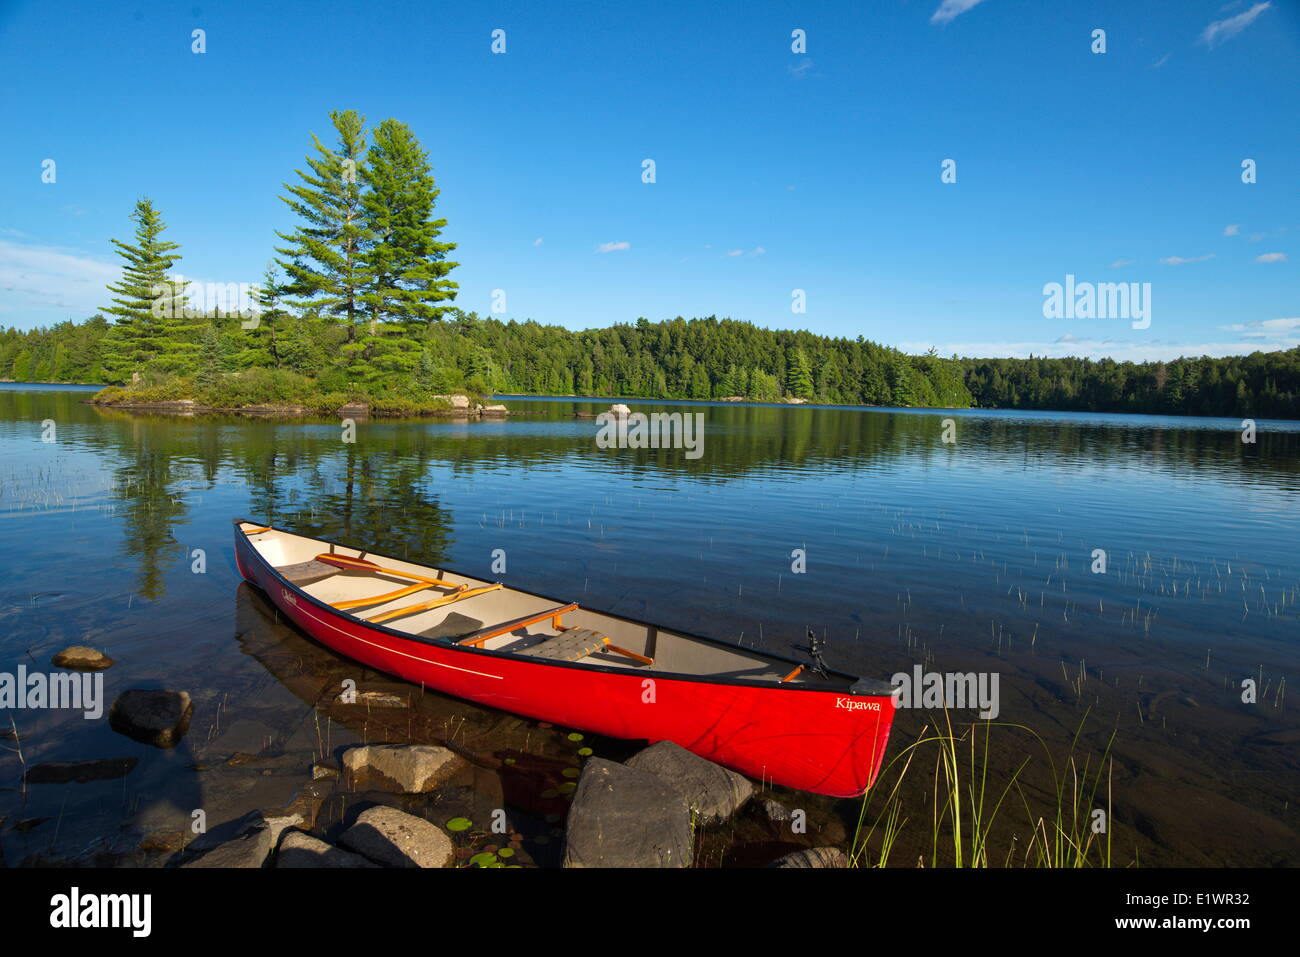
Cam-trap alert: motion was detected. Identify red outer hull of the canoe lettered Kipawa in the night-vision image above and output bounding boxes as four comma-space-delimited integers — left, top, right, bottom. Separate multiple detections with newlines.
235, 527, 894, 797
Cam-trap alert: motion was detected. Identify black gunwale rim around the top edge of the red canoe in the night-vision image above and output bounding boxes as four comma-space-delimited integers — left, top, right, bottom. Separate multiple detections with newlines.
231, 519, 891, 698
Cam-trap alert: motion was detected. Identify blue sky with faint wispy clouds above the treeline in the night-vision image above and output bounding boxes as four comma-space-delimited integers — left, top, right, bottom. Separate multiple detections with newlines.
0, 0, 1300, 359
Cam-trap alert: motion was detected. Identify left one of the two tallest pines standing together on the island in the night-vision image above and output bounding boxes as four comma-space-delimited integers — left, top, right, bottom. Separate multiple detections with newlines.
276, 109, 367, 356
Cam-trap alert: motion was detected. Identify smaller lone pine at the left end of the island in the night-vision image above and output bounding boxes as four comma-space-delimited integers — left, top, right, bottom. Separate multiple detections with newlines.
103, 196, 186, 381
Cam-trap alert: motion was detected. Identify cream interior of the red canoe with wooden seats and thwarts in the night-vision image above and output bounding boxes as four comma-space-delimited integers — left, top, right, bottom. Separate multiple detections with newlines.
241, 523, 853, 690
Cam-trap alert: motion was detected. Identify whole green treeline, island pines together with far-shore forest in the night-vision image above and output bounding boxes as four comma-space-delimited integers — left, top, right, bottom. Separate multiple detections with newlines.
0, 111, 1300, 417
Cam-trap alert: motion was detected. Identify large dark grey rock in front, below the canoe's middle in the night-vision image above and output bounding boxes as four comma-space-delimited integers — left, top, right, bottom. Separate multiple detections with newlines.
564, 758, 694, 867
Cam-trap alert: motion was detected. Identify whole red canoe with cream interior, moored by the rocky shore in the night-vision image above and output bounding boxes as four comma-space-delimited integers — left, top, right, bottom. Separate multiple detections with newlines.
235, 520, 894, 797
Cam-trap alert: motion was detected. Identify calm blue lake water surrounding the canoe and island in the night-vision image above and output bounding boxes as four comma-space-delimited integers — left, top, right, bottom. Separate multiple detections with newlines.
0, 387, 1300, 865
